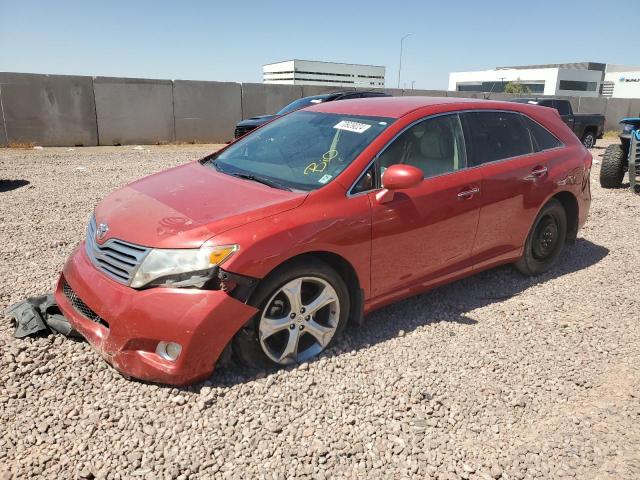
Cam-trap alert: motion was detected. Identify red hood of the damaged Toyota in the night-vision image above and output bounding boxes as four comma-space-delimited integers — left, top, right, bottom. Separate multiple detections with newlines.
95, 162, 306, 248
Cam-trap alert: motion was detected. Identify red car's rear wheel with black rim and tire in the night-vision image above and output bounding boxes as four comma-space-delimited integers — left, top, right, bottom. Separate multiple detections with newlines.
516, 199, 567, 275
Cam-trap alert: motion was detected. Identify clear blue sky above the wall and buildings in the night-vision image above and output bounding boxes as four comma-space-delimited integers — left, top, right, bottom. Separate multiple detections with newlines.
0, 0, 640, 88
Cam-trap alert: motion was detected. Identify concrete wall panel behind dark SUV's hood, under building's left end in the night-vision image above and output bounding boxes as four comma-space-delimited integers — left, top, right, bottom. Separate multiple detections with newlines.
242, 83, 307, 119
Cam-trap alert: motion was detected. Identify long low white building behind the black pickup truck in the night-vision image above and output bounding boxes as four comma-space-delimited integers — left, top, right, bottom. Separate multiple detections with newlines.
449, 62, 606, 97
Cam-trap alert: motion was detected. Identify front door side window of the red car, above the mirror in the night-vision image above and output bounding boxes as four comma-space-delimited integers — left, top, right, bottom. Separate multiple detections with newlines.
378, 114, 467, 178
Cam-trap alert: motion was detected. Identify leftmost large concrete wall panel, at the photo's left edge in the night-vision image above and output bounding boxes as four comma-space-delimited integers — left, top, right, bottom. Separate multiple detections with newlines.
0, 73, 98, 146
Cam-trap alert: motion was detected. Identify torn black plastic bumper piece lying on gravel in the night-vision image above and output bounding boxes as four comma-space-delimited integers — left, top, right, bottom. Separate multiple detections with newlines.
4, 293, 79, 338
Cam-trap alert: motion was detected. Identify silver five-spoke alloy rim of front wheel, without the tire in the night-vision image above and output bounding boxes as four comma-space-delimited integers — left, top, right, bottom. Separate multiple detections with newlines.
258, 277, 340, 365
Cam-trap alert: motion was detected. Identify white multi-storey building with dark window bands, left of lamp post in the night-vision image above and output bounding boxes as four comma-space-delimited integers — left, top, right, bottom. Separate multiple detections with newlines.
262, 60, 385, 88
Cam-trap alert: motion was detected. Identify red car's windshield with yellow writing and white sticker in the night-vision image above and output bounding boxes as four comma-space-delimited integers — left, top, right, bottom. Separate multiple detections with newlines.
208, 111, 394, 191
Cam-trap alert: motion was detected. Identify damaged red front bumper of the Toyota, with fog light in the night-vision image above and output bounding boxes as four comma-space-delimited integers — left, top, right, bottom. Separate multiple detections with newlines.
55, 244, 257, 385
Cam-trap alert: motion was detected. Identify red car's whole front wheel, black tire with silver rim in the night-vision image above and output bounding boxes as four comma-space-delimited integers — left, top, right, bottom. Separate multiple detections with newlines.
233, 259, 349, 368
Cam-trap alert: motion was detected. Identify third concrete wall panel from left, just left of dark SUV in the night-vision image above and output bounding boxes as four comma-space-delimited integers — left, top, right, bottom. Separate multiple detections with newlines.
173, 80, 242, 143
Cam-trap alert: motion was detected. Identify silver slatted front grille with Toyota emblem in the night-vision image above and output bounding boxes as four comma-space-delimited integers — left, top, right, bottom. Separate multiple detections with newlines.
85, 217, 150, 285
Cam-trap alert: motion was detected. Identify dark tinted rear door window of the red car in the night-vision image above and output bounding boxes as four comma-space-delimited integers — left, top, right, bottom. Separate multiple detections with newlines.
464, 112, 534, 165
